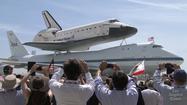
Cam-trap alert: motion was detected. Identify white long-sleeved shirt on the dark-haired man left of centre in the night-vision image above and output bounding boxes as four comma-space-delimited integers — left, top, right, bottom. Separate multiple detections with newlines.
49, 70, 94, 105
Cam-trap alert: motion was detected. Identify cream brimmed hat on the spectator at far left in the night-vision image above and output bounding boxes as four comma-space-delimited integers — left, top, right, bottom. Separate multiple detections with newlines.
2, 74, 20, 90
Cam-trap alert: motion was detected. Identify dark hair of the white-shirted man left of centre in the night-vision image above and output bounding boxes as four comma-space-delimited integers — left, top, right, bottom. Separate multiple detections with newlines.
64, 59, 82, 80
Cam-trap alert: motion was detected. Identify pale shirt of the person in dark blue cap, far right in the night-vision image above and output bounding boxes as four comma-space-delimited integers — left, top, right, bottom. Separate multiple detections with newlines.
153, 70, 187, 105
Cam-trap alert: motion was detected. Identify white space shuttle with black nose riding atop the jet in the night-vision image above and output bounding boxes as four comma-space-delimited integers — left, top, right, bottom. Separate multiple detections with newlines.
24, 11, 137, 51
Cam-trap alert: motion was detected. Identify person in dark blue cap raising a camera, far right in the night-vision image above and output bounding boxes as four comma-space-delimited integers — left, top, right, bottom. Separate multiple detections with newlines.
153, 64, 187, 105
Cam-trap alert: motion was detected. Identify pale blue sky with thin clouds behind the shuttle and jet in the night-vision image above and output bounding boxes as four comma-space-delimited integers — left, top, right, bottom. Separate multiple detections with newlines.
0, 0, 187, 69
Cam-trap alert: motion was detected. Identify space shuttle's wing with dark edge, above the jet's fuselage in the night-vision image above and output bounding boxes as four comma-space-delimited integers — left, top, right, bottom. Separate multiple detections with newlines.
23, 37, 103, 51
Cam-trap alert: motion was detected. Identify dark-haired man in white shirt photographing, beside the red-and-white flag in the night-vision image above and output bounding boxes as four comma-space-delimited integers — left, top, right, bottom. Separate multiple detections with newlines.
95, 61, 138, 105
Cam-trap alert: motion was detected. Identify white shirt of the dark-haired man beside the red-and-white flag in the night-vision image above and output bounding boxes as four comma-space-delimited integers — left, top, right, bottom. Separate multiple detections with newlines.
95, 76, 138, 105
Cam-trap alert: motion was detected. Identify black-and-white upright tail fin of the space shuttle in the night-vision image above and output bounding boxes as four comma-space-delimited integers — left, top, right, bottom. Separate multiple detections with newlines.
42, 10, 62, 30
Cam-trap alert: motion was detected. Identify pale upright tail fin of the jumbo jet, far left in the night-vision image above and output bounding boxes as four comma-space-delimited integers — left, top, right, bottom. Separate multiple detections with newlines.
7, 31, 29, 58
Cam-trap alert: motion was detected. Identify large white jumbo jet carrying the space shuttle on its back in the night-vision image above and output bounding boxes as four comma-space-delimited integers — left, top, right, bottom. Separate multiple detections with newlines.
1, 32, 183, 73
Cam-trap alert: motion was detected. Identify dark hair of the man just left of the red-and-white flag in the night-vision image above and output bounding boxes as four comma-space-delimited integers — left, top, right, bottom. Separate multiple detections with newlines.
112, 71, 128, 90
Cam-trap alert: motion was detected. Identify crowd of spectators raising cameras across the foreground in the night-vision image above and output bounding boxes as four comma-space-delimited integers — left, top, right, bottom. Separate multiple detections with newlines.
0, 59, 187, 105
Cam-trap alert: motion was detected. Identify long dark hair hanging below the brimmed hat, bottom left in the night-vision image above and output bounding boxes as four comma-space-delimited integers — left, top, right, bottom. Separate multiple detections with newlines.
27, 91, 51, 105
